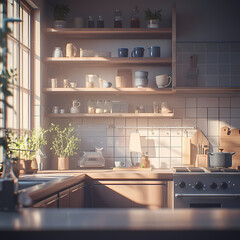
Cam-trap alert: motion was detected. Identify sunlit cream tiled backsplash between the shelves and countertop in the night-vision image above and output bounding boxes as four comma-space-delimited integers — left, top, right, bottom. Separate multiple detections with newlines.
68, 95, 240, 168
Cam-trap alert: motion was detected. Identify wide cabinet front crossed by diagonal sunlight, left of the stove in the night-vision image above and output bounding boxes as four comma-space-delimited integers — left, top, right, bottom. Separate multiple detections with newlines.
91, 181, 167, 208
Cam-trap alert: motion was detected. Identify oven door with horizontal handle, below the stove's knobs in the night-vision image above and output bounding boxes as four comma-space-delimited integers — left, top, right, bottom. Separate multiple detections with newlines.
174, 193, 240, 208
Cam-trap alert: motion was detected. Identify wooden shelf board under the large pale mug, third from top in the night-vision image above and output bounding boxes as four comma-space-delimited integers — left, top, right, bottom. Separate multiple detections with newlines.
43, 87, 174, 95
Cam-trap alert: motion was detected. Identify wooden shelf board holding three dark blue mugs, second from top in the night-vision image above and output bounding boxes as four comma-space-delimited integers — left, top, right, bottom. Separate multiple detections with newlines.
44, 57, 172, 65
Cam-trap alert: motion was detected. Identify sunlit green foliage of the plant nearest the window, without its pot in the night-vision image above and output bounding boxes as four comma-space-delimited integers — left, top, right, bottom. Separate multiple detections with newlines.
8, 128, 48, 160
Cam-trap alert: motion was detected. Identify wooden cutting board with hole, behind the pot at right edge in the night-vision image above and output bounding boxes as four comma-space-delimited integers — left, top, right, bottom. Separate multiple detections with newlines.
219, 126, 240, 169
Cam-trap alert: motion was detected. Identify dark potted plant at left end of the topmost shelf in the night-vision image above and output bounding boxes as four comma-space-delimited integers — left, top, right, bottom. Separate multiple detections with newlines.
53, 3, 70, 28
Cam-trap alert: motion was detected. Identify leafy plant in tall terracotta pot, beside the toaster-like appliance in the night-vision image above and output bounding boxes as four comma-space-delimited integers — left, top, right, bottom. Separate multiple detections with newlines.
49, 123, 81, 170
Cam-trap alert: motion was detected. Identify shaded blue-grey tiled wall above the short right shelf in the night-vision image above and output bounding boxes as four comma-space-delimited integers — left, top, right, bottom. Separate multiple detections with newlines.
177, 43, 240, 87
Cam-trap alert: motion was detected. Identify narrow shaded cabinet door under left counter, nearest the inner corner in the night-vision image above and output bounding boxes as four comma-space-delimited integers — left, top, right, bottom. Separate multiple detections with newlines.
69, 183, 84, 208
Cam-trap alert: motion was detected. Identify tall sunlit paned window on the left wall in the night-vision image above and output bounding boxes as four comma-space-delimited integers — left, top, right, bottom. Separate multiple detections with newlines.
6, 0, 32, 130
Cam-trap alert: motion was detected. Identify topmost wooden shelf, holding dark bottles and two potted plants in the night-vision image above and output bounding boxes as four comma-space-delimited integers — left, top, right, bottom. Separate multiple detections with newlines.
44, 28, 172, 39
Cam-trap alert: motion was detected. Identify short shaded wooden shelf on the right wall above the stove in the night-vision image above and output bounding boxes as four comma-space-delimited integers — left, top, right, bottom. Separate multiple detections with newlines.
174, 87, 240, 94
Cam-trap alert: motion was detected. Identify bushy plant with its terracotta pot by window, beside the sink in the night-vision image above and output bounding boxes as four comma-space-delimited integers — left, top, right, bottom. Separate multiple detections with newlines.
8, 128, 47, 173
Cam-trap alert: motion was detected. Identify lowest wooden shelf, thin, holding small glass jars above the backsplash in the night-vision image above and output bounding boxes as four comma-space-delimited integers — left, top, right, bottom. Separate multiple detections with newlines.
46, 113, 174, 118
